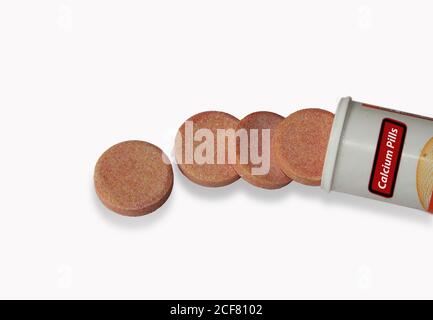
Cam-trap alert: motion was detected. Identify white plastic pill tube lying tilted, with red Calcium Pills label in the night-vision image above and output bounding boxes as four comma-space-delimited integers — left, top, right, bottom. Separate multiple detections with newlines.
322, 98, 433, 213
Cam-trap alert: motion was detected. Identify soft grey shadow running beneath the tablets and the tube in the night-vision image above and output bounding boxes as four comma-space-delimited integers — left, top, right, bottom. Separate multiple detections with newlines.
90, 166, 433, 229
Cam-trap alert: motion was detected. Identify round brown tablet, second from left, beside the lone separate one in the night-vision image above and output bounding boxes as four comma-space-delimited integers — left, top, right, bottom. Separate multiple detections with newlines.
175, 111, 239, 187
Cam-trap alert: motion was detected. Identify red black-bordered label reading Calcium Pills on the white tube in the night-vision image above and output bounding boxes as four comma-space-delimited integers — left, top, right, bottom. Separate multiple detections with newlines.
369, 119, 407, 198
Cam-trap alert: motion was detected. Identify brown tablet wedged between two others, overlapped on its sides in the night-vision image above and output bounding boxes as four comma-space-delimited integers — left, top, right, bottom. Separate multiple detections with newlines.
233, 111, 292, 189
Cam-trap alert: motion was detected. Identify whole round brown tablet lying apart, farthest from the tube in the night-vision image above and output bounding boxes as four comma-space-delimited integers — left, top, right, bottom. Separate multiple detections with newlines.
94, 141, 173, 216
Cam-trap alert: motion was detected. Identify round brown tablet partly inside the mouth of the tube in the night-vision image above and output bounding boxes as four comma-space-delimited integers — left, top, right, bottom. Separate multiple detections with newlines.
272, 109, 334, 186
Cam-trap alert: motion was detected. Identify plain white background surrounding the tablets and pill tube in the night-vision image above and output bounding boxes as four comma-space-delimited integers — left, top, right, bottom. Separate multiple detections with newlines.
0, 0, 433, 299
